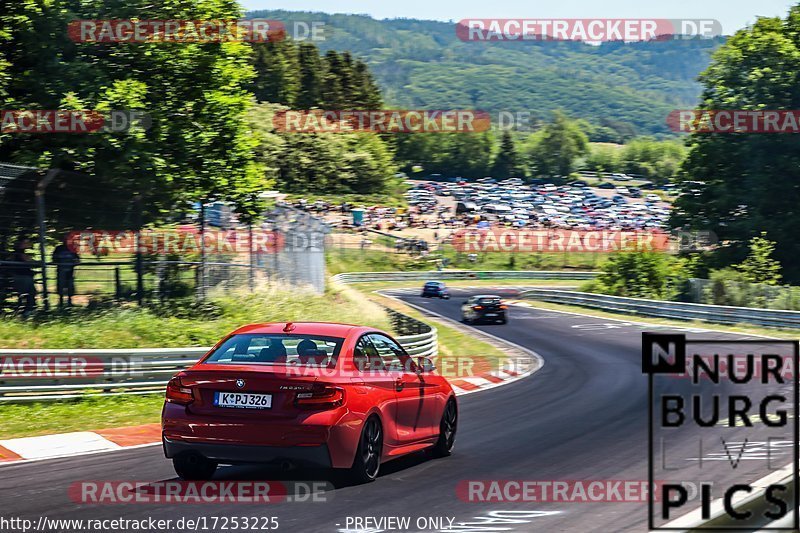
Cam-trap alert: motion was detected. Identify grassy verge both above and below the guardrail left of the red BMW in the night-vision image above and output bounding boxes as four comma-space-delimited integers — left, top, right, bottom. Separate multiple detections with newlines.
0, 288, 391, 439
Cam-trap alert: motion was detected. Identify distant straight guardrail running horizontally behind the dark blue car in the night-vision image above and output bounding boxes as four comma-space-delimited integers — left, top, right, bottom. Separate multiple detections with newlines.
333, 270, 597, 283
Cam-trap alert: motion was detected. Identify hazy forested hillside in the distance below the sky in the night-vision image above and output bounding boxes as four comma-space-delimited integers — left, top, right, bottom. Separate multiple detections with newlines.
247, 11, 721, 142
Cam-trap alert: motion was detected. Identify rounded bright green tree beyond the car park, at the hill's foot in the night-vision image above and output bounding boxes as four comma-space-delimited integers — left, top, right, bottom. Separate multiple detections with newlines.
528, 111, 589, 177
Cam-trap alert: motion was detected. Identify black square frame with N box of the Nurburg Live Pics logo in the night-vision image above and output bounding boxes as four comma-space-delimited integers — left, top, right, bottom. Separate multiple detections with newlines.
642, 332, 800, 531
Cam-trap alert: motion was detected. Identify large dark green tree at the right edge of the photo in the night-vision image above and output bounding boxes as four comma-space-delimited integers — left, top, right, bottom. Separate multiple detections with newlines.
671, 6, 800, 282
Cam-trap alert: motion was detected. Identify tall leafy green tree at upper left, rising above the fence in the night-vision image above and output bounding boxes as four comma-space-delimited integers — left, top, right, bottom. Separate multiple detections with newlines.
0, 0, 269, 227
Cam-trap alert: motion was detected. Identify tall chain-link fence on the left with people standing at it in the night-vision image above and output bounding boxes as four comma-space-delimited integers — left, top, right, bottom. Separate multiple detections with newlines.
0, 160, 328, 315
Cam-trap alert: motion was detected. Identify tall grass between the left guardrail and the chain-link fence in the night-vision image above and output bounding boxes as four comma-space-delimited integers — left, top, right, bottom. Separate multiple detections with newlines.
0, 289, 390, 349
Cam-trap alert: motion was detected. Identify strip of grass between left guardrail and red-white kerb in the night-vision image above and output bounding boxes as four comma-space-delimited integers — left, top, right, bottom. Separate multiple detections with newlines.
0, 394, 164, 439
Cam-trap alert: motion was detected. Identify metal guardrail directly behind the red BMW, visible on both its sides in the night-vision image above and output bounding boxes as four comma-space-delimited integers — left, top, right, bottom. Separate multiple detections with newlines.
0, 310, 439, 402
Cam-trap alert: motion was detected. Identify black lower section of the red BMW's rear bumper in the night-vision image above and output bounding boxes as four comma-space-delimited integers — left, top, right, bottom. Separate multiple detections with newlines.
162, 437, 332, 468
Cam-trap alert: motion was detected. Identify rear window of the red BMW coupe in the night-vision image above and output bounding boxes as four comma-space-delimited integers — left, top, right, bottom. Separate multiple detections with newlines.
204, 333, 343, 368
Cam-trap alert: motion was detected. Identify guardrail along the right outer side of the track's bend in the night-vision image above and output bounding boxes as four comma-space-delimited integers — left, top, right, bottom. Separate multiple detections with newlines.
520, 289, 800, 328
